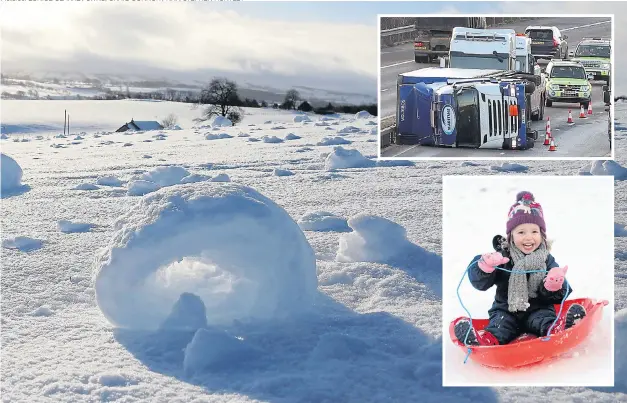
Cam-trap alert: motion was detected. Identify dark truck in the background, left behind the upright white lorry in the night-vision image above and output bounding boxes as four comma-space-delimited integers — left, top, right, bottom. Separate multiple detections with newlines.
414, 17, 486, 63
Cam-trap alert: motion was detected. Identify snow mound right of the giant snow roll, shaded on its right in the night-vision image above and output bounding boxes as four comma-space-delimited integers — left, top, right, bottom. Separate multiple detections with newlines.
336, 214, 438, 267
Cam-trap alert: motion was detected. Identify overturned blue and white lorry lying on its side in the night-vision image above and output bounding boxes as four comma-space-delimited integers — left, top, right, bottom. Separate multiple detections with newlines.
393, 68, 538, 150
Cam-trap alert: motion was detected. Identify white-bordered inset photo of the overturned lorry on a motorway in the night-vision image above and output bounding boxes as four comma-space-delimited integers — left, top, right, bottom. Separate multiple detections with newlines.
377, 14, 615, 161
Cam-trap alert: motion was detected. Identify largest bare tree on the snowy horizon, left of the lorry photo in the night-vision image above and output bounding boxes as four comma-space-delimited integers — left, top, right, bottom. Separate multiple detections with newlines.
199, 78, 242, 123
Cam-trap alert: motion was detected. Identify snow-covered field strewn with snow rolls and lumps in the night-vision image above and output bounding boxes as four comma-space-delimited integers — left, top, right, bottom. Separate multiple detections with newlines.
0, 101, 627, 403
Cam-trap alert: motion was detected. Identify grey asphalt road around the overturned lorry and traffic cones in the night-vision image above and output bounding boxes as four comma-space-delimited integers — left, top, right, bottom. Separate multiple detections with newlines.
380, 17, 612, 157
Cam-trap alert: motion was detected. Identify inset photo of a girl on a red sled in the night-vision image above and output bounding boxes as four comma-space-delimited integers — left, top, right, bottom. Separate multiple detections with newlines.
442, 175, 614, 386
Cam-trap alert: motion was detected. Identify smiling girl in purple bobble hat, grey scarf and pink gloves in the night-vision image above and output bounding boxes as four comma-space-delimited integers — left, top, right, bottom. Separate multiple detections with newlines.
455, 191, 586, 346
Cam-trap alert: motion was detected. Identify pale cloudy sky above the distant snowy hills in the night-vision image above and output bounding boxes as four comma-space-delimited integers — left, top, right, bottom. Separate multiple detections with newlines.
0, 1, 627, 95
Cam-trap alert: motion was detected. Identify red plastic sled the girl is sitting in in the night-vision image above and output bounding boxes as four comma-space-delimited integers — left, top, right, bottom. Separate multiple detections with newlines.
449, 298, 609, 368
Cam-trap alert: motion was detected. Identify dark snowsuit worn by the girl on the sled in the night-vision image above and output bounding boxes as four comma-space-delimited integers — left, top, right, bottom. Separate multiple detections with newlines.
468, 254, 572, 344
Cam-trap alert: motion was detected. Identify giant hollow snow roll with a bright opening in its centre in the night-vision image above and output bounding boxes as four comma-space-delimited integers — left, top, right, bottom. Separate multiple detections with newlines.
95, 182, 317, 329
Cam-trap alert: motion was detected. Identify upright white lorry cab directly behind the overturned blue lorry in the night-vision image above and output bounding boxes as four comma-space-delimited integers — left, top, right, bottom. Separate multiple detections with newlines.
448, 27, 516, 70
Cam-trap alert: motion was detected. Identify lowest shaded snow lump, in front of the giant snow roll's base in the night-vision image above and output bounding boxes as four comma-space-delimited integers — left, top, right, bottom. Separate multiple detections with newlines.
183, 329, 260, 375
